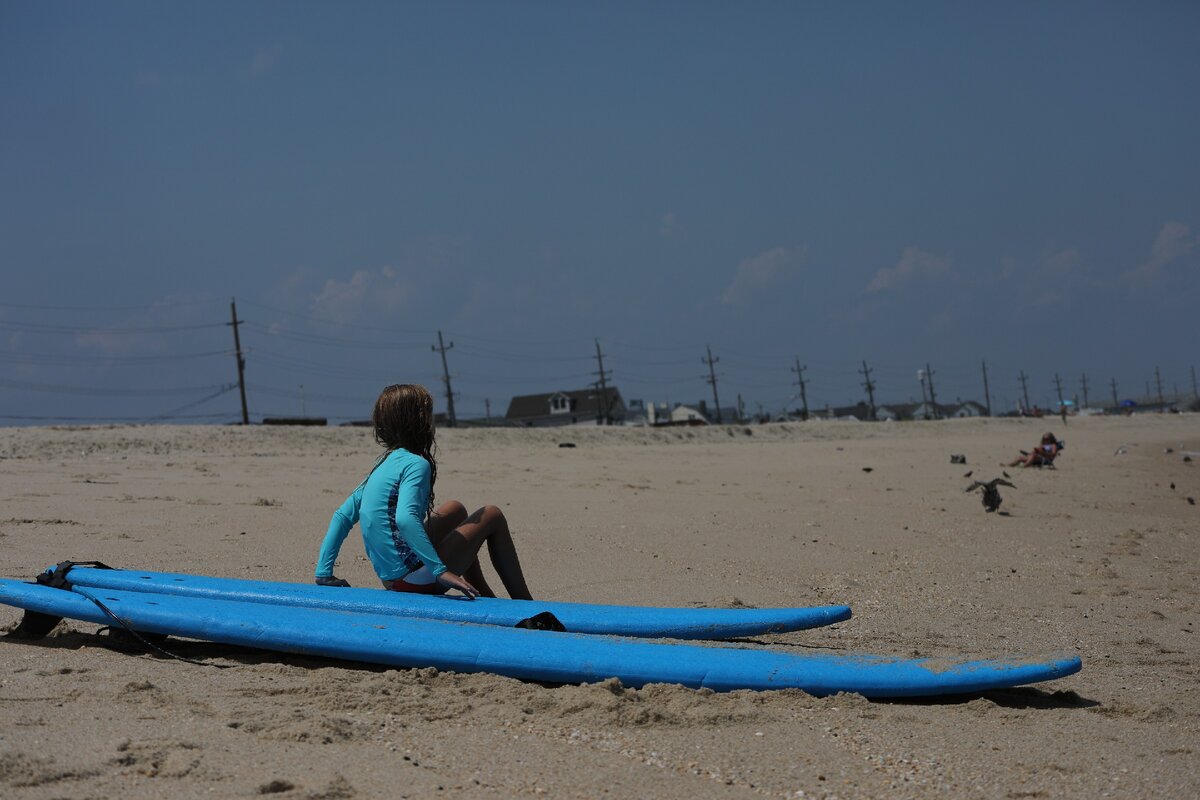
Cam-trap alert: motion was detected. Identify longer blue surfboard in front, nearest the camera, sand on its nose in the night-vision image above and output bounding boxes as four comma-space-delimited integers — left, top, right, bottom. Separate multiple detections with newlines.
0, 579, 1081, 697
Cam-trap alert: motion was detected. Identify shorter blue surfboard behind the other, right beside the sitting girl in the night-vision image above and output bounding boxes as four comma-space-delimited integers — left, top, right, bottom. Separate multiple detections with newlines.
49, 566, 850, 639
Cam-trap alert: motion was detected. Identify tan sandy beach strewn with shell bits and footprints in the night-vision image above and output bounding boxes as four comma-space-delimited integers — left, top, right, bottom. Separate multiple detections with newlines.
0, 415, 1200, 800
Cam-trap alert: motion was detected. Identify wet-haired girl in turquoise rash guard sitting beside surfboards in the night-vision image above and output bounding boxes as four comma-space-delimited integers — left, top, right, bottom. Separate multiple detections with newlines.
316, 384, 532, 600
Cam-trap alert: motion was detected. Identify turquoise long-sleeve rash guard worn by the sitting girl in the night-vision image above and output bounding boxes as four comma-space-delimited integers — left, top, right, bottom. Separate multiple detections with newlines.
317, 450, 446, 583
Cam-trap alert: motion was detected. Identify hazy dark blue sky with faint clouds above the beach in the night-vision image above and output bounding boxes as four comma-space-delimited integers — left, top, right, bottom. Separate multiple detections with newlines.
0, 1, 1200, 425
